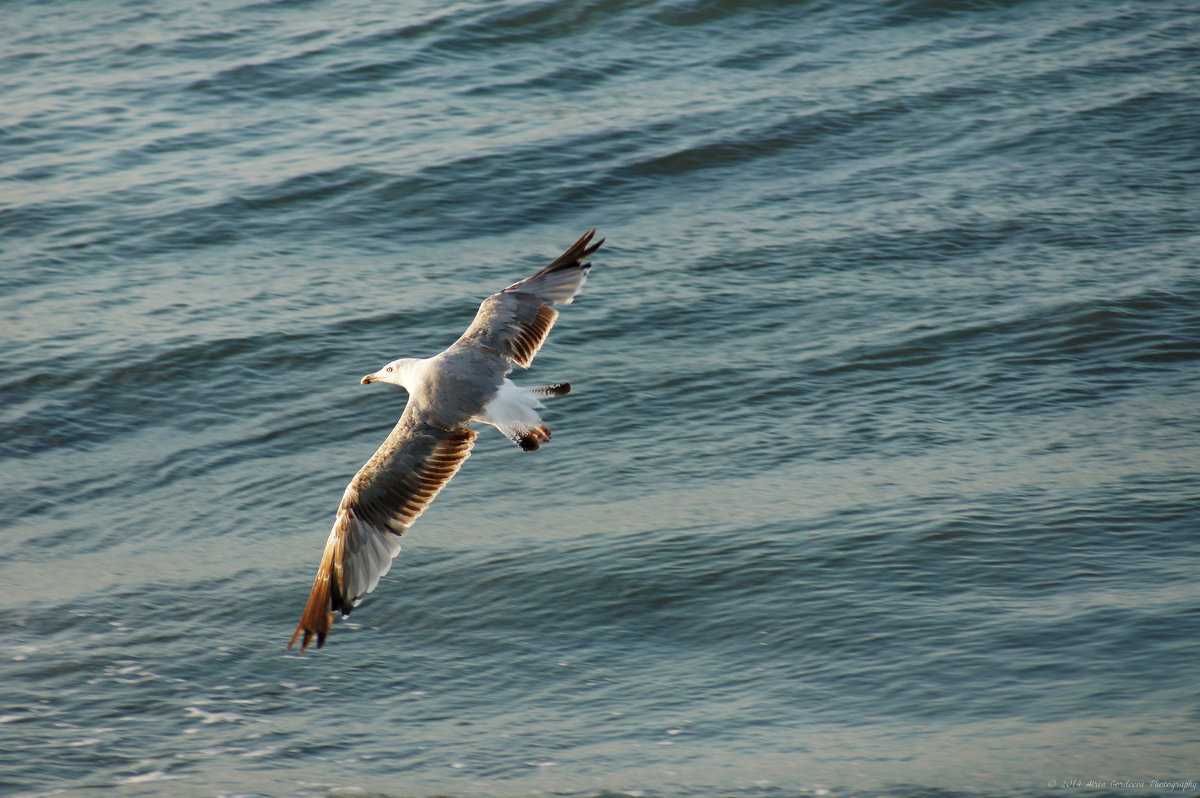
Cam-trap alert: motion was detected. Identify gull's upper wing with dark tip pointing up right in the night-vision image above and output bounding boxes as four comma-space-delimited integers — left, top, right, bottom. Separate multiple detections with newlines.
451, 230, 604, 368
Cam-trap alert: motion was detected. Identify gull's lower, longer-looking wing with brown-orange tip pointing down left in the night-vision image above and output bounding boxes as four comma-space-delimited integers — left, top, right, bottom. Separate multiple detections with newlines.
288, 410, 475, 652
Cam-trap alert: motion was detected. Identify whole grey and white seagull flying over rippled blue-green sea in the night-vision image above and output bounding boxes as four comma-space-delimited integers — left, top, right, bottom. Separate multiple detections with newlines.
288, 230, 604, 653
